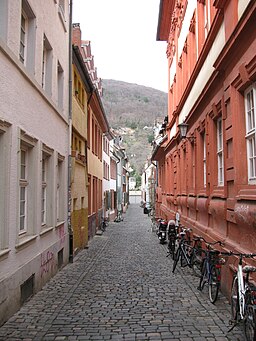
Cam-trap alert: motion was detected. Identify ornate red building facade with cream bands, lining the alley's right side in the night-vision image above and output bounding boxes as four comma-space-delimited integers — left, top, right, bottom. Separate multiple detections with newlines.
152, 0, 256, 291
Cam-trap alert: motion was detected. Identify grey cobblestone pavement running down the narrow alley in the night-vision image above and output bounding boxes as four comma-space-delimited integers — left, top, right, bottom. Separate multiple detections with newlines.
0, 204, 244, 341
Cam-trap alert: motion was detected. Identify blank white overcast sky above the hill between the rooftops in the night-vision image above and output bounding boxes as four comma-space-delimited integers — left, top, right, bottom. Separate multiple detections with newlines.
73, 0, 168, 92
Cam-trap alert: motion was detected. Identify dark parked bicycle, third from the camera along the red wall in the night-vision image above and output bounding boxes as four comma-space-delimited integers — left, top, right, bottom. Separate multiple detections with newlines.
172, 227, 201, 275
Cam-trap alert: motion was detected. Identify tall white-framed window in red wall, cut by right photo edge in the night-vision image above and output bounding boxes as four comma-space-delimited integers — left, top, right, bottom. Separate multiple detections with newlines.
245, 83, 256, 184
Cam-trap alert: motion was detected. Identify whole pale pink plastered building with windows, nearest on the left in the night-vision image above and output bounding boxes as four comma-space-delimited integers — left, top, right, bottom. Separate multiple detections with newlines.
0, 0, 69, 324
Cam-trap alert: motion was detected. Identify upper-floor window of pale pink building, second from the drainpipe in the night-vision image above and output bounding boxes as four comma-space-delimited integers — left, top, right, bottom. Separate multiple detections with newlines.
41, 35, 52, 95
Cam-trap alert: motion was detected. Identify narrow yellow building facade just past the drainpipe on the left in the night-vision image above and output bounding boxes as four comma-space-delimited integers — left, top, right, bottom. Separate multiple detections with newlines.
71, 47, 93, 254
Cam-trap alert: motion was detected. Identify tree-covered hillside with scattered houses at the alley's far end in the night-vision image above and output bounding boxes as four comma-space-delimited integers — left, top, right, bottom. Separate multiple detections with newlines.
102, 79, 167, 173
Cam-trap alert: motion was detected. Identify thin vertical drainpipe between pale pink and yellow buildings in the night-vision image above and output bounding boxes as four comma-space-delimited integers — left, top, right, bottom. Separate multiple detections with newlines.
68, 0, 73, 263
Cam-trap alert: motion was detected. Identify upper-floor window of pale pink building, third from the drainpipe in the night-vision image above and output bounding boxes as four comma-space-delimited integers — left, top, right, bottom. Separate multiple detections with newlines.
19, 0, 36, 71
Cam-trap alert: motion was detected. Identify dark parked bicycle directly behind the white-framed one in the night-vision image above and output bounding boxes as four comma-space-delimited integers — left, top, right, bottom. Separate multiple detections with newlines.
198, 237, 225, 303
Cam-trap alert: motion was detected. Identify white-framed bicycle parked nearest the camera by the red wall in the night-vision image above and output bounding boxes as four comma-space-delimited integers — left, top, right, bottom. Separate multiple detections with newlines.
228, 252, 256, 341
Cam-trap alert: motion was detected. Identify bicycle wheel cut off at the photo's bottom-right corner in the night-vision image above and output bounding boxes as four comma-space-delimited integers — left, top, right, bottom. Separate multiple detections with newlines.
244, 290, 256, 341
